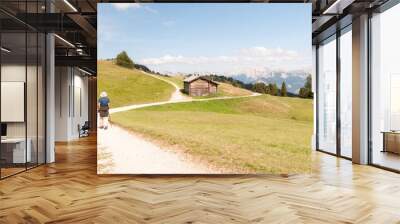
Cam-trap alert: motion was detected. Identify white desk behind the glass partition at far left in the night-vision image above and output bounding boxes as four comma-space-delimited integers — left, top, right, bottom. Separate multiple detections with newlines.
1, 138, 32, 163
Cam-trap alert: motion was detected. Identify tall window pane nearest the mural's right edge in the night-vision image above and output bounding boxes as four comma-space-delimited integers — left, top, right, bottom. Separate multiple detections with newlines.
317, 37, 336, 153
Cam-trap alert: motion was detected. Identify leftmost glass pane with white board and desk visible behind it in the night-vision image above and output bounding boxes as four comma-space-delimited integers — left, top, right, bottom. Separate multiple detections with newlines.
0, 32, 27, 178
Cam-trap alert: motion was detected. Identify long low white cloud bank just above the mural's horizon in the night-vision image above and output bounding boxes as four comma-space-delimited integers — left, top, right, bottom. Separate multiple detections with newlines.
139, 47, 311, 76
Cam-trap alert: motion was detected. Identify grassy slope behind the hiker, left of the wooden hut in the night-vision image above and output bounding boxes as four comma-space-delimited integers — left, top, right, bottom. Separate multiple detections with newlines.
97, 61, 175, 108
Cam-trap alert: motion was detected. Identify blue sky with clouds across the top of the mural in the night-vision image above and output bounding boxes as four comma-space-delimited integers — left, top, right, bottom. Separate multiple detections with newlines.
98, 3, 311, 75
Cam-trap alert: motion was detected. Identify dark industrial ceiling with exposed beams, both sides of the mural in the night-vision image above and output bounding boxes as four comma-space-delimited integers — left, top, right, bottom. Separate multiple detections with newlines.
0, 0, 396, 74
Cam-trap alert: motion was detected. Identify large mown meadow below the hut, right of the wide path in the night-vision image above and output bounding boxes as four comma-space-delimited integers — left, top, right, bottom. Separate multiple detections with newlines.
112, 95, 313, 174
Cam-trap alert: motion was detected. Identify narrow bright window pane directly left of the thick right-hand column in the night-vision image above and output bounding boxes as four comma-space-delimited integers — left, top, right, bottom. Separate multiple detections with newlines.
340, 27, 353, 158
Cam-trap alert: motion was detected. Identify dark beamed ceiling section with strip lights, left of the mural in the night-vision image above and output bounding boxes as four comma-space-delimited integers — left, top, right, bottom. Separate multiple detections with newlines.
0, 0, 97, 74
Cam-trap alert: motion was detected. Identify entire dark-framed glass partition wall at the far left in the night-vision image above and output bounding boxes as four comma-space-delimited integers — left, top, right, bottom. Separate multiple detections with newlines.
0, 0, 46, 178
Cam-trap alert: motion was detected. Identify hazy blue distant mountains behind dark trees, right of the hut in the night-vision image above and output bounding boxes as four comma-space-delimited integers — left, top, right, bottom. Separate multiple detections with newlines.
231, 72, 308, 94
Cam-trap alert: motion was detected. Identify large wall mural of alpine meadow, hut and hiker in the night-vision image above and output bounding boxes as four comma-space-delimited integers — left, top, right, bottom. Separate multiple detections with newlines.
98, 3, 313, 174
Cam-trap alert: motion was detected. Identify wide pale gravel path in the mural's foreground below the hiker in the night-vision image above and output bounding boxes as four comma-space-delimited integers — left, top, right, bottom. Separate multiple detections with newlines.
97, 125, 219, 174
